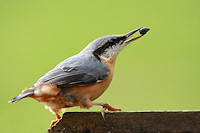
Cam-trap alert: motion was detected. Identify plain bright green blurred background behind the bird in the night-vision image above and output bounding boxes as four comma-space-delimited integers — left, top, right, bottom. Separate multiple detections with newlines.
0, 0, 200, 133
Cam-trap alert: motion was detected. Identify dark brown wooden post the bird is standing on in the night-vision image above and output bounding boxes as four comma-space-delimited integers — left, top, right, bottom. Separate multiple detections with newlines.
48, 111, 200, 133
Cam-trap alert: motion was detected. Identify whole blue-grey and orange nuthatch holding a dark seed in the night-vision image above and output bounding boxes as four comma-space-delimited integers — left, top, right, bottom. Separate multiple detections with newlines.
9, 27, 150, 130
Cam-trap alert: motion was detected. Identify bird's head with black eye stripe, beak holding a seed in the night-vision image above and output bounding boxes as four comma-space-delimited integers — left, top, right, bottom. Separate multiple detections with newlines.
81, 28, 149, 60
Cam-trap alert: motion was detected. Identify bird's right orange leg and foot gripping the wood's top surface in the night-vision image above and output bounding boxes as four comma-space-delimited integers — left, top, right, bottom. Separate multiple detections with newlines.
92, 103, 121, 122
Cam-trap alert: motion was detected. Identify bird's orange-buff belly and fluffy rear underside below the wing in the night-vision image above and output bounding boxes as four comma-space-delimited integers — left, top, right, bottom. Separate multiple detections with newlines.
31, 76, 112, 112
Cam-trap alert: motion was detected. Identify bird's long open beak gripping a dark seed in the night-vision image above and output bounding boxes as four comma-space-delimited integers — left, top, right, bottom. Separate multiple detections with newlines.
124, 27, 150, 44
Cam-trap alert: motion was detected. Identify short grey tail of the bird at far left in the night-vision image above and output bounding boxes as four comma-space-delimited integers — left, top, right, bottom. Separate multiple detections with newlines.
8, 89, 34, 103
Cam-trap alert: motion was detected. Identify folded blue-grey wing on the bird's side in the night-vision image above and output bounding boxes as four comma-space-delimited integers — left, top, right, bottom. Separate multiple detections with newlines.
35, 54, 109, 88
